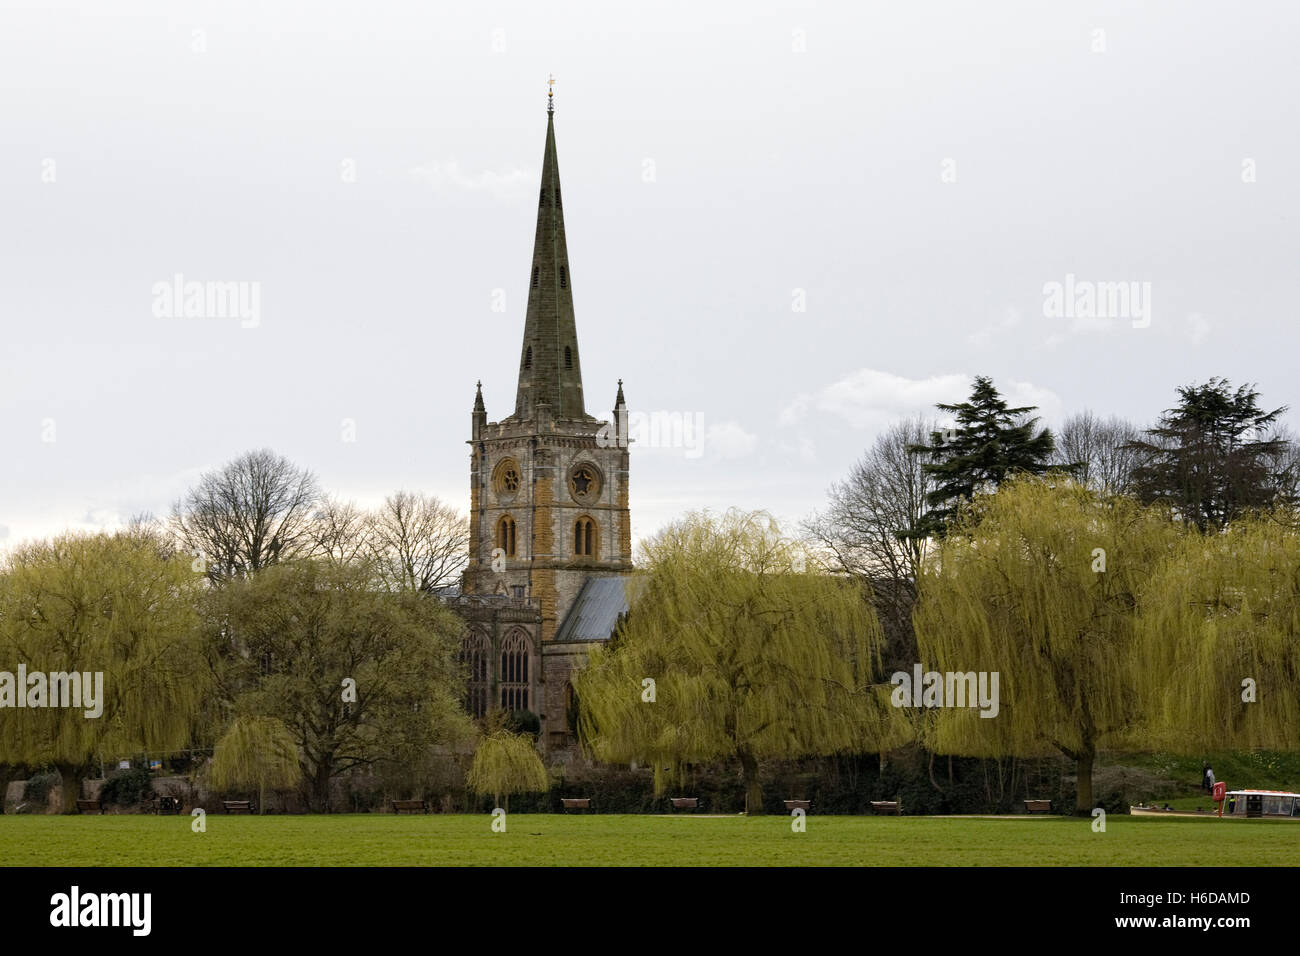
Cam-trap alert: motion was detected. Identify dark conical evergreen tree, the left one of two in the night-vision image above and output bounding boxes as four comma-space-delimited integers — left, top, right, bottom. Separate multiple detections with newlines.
915, 376, 1056, 537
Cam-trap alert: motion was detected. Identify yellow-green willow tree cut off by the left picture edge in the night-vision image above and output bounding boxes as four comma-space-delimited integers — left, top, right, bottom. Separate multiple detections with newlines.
0, 533, 208, 809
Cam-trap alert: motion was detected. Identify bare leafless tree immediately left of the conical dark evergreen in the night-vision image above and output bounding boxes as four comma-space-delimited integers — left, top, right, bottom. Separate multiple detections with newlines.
803, 416, 937, 605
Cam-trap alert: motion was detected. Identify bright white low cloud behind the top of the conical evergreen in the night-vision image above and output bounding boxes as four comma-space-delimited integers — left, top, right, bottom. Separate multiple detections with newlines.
780, 368, 1061, 428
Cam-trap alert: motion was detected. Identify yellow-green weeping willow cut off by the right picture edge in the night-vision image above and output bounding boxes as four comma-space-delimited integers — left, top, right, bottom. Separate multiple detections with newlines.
1138, 516, 1300, 752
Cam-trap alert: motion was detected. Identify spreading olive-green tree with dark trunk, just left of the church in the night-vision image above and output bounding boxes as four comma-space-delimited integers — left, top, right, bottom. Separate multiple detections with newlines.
204, 559, 471, 809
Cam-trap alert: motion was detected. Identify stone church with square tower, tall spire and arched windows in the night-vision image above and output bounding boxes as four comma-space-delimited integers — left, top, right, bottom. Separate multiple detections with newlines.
451, 99, 632, 757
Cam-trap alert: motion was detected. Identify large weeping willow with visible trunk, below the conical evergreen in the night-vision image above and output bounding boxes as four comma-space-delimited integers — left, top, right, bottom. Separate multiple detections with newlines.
914, 477, 1178, 813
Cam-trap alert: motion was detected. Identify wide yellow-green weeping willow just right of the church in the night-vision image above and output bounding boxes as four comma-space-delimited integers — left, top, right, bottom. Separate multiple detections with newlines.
575, 511, 901, 813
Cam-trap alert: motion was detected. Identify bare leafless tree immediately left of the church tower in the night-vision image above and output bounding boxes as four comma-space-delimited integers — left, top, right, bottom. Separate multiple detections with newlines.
369, 492, 469, 592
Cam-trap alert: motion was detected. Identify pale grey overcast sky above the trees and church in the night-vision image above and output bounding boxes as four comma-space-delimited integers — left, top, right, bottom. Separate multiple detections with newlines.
0, 0, 1300, 545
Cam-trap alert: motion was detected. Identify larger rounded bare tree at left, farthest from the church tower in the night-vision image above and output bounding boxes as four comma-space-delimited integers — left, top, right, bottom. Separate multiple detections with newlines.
172, 449, 321, 580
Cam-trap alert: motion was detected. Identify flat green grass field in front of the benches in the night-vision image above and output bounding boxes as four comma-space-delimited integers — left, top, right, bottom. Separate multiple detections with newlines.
0, 814, 1300, 866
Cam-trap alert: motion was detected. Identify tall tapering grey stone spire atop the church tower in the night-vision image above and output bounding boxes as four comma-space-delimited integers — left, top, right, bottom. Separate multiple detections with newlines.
514, 77, 590, 421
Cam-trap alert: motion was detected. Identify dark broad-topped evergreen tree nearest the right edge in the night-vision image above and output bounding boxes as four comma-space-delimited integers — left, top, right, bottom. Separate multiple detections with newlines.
1131, 378, 1290, 532
